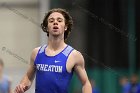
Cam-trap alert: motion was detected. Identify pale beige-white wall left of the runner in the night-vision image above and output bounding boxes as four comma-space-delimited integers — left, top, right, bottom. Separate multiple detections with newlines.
0, 0, 49, 93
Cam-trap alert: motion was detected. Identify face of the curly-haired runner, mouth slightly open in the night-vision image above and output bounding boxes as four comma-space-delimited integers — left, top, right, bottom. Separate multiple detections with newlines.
47, 12, 66, 36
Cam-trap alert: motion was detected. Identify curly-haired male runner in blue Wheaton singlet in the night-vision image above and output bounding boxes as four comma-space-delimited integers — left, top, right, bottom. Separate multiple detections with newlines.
15, 8, 92, 93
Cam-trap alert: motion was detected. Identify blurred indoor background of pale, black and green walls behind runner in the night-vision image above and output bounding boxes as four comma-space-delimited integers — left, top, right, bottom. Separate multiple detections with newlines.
0, 0, 140, 93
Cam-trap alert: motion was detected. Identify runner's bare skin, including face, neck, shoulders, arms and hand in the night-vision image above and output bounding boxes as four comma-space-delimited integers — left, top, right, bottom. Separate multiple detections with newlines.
15, 12, 92, 93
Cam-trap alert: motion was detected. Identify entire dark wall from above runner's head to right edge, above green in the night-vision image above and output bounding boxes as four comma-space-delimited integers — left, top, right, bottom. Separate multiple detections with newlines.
51, 0, 140, 69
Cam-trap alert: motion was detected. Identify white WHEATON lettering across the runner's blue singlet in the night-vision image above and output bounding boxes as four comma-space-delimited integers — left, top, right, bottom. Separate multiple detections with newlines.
36, 64, 63, 73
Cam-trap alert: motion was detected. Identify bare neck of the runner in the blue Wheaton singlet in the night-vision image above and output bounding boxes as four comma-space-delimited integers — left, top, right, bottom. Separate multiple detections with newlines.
48, 37, 66, 50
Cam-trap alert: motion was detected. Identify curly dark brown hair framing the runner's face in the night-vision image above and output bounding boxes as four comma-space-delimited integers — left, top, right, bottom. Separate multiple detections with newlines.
41, 8, 73, 40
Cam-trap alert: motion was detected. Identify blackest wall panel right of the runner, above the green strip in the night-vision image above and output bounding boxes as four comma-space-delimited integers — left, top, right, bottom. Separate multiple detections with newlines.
87, 0, 128, 68
